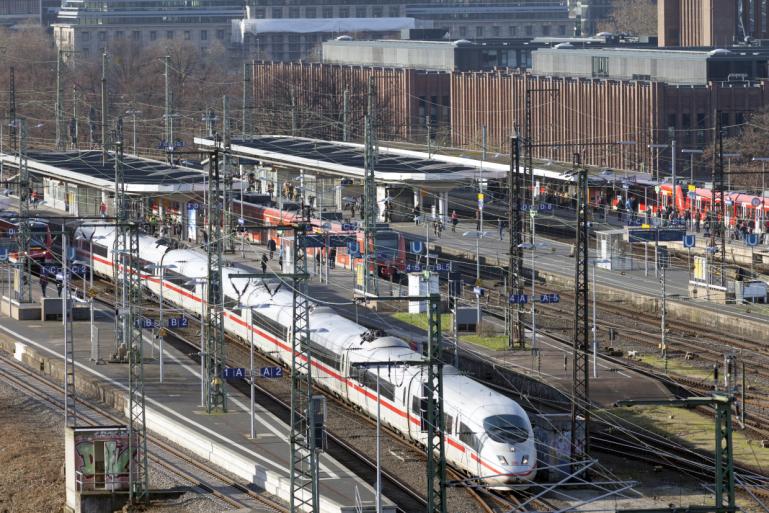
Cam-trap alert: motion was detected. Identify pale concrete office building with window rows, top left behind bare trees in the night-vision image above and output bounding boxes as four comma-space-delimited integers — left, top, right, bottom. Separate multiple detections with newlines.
53, 0, 245, 58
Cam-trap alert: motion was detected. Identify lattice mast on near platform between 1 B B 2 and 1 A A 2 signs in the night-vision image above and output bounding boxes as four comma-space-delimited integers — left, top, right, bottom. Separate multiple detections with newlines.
206, 140, 227, 413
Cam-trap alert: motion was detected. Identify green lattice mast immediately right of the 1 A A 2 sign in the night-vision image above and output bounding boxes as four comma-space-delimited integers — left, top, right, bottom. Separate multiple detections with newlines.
290, 219, 320, 513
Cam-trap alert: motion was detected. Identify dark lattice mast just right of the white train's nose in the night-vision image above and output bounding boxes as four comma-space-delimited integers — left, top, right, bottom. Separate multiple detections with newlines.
571, 157, 590, 472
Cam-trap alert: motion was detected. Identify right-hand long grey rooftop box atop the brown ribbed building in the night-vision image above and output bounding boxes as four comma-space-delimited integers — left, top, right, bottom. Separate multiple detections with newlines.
532, 45, 769, 85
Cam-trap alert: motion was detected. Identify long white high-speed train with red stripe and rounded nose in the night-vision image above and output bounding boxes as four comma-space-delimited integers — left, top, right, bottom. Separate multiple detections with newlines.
77, 226, 537, 487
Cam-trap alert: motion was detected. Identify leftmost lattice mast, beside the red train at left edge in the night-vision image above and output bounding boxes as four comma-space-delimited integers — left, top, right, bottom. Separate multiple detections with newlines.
14, 118, 32, 303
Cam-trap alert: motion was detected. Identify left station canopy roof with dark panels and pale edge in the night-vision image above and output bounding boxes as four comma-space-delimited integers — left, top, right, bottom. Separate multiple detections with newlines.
0, 150, 206, 194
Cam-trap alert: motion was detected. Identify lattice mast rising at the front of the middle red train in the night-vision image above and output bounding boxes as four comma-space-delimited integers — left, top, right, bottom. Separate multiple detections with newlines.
362, 76, 378, 295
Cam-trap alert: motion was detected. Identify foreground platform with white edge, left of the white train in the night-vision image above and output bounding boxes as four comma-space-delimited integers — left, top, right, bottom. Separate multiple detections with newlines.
0, 282, 395, 513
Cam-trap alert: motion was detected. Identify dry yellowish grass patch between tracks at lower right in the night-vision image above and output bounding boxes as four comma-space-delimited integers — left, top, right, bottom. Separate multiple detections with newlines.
607, 406, 769, 471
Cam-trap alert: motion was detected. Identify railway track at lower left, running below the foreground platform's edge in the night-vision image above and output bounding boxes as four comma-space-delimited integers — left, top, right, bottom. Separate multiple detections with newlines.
0, 346, 289, 513
